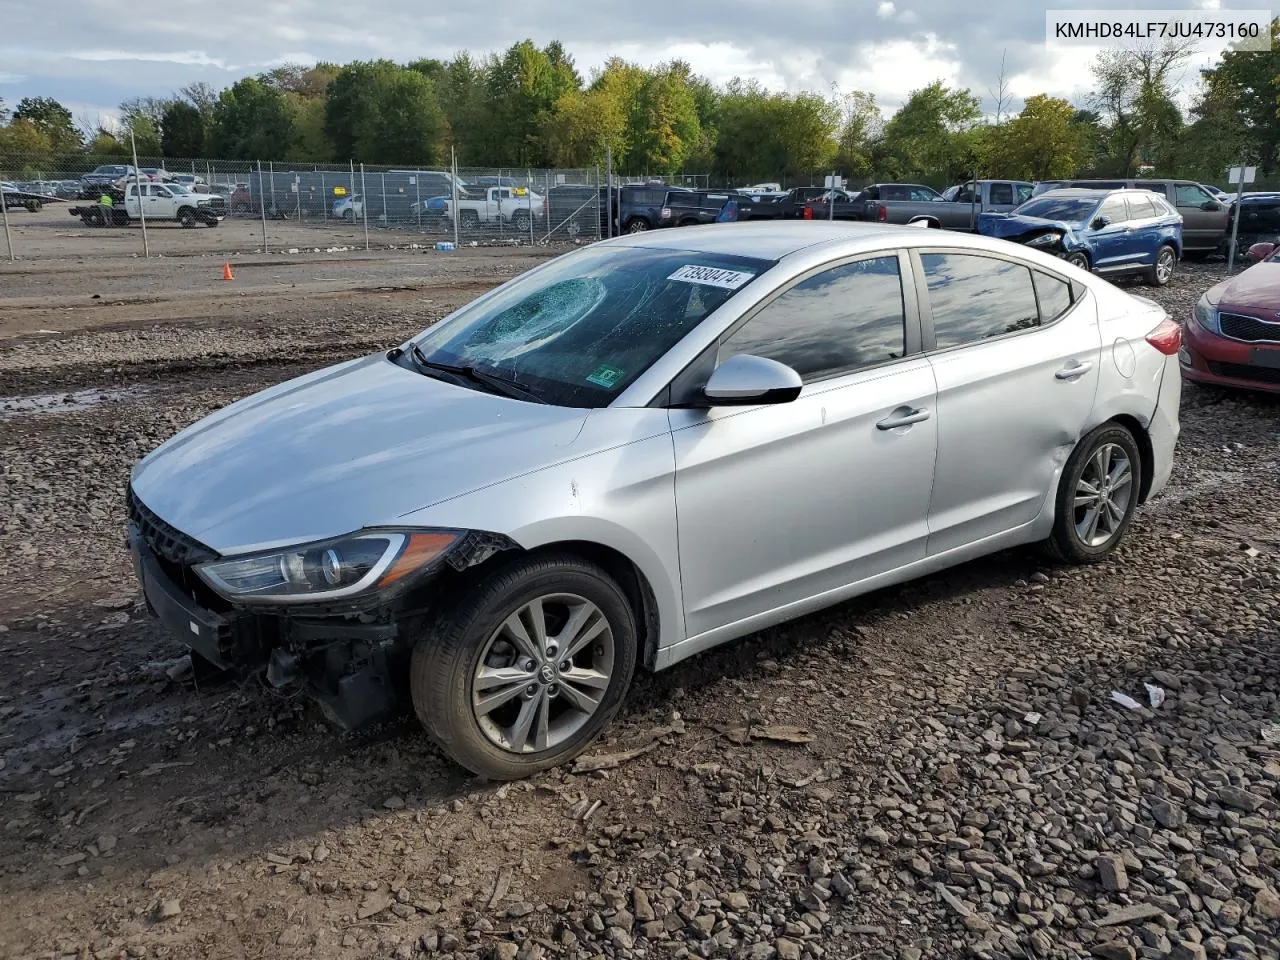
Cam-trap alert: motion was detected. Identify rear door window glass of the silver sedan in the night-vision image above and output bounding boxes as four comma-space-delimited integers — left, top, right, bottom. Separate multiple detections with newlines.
920, 253, 1039, 349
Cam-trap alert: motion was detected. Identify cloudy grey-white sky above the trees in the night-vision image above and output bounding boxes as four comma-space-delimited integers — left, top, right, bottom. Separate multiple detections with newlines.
0, 0, 1262, 126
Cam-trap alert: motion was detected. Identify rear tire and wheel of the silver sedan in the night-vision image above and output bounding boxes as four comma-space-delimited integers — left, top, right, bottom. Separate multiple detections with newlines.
1044, 424, 1143, 563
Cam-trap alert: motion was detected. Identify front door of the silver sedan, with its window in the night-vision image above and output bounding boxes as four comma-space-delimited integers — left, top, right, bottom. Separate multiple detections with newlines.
671, 252, 937, 636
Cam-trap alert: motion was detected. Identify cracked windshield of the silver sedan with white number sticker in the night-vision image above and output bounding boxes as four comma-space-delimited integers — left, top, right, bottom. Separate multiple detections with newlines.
417, 246, 774, 407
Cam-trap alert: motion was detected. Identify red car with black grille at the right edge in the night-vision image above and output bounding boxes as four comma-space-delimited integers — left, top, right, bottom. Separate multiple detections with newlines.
1179, 243, 1280, 393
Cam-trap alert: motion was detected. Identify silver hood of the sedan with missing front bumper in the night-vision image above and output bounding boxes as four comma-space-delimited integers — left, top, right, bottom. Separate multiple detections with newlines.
132, 353, 589, 553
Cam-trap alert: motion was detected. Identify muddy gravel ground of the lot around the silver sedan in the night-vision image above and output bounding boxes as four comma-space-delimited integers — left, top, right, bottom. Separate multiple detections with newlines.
0, 244, 1280, 960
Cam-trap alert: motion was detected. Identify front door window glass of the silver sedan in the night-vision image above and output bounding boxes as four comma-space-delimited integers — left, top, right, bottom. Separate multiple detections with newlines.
719, 256, 905, 380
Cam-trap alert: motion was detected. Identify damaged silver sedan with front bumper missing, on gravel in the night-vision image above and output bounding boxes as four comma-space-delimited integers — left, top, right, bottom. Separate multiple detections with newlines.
128, 221, 1181, 780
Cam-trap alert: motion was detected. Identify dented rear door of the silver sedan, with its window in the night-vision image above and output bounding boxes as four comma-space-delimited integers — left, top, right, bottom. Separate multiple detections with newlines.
915, 250, 1102, 556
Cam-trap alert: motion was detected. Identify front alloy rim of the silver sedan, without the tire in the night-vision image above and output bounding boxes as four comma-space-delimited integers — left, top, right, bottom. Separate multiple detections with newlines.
471, 594, 616, 754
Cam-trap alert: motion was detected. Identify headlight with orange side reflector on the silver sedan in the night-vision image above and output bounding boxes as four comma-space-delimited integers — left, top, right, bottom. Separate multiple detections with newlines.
196, 530, 462, 603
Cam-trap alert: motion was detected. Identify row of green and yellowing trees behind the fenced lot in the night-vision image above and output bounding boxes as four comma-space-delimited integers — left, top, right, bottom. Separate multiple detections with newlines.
0, 24, 1280, 184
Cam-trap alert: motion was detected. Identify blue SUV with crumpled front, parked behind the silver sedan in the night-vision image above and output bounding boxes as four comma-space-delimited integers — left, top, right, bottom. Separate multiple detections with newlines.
978, 189, 1183, 287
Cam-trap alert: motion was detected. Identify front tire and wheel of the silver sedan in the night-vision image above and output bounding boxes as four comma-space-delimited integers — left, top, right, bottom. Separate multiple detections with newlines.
410, 554, 637, 780
